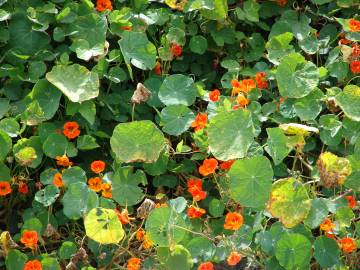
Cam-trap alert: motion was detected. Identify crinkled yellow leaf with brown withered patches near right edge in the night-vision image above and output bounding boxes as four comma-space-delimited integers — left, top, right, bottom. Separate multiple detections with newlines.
316, 152, 352, 188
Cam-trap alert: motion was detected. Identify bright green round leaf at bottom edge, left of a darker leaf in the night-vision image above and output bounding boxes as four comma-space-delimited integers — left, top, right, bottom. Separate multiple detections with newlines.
275, 233, 312, 270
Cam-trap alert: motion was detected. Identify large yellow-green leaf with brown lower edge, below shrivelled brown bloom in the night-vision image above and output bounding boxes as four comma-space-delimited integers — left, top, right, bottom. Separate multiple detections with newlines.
110, 120, 165, 163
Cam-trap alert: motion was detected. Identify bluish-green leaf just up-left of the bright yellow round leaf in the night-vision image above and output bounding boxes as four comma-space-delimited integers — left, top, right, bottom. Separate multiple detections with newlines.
62, 182, 98, 220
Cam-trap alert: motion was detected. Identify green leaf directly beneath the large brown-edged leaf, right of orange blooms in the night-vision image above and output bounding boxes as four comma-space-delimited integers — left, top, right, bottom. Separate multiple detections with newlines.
112, 167, 147, 206
